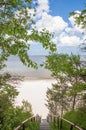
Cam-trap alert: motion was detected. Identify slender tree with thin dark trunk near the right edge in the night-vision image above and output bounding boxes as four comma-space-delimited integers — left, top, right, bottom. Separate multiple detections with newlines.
68, 55, 86, 110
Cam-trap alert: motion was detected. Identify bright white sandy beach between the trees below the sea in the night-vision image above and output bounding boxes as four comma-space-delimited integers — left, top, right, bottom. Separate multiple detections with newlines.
16, 78, 55, 118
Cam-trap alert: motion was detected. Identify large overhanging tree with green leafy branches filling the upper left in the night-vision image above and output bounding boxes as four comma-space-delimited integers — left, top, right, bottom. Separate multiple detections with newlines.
0, 0, 56, 67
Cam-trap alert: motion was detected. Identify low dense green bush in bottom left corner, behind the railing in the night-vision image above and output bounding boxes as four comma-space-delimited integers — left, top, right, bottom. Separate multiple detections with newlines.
1, 106, 32, 130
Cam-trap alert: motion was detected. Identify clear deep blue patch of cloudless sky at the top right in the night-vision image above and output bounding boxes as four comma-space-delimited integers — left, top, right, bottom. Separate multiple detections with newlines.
49, 0, 86, 21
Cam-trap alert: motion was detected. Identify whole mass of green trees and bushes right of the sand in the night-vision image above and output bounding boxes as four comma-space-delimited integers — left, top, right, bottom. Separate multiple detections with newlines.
44, 54, 86, 130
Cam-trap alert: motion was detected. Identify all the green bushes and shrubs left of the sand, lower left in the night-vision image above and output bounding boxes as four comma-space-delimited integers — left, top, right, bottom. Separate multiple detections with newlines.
0, 74, 33, 130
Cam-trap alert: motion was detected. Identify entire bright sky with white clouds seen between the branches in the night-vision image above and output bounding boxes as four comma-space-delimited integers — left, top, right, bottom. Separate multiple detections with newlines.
30, 0, 86, 55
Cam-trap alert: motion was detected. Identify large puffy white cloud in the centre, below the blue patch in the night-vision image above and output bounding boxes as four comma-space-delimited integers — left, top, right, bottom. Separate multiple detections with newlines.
36, 12, 67, 33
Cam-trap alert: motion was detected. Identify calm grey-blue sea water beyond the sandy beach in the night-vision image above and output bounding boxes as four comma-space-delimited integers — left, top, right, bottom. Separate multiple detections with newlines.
2, 55, 50, 78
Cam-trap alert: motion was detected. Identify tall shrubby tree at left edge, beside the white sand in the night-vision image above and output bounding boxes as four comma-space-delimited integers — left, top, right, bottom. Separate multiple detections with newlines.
0, 75, 18, 129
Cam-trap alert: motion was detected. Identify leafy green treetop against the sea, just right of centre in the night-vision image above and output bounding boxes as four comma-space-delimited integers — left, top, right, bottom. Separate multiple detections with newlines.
44, 54, 70, 79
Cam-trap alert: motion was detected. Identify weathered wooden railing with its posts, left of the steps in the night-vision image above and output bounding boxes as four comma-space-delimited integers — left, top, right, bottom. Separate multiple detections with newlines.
14, 115, 41, 130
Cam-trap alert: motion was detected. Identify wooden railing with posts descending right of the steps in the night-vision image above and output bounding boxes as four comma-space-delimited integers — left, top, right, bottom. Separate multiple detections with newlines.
47, 115, 84, 130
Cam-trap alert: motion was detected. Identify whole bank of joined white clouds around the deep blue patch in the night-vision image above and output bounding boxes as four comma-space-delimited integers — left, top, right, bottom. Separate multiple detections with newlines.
36, 0, 83, 46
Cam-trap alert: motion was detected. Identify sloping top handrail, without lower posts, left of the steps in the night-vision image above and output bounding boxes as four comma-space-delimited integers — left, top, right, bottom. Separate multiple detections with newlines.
14, 115, 41, 130
